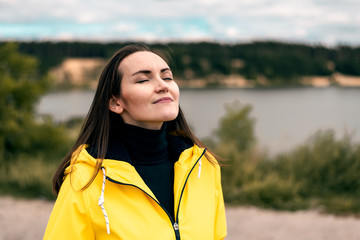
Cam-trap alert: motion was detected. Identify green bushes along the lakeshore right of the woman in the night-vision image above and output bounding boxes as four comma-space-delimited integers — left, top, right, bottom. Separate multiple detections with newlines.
209, 103, 360, 214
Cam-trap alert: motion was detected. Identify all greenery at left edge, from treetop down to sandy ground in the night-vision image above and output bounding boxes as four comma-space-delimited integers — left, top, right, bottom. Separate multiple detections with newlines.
0, 43, 71, 198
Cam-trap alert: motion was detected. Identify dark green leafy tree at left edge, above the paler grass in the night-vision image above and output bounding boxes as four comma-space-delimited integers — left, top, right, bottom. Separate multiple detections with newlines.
0, 43, 66, 164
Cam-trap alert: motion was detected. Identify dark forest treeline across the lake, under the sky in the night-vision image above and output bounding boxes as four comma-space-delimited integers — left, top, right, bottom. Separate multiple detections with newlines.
1, 41, 360, 86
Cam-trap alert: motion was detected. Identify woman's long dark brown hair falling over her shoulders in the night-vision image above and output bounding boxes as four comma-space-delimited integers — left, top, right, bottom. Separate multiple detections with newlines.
52, 45, 213, 195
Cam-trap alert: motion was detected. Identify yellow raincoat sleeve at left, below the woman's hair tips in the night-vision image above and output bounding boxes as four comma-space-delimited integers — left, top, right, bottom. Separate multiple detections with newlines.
44, 174, 95, 240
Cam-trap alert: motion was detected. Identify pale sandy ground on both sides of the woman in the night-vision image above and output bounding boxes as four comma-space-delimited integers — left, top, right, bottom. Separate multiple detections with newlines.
0, 197, 360, 240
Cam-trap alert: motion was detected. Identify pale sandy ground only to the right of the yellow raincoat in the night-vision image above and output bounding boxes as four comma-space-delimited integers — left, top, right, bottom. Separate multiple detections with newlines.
227, 207, 360, 240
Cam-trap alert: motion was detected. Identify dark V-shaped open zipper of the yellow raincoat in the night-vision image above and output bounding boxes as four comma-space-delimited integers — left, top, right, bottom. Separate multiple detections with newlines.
106, 149, 206, 240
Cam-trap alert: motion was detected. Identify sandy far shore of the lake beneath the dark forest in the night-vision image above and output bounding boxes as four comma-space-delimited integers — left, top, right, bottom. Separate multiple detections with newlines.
50, 58, 360, 90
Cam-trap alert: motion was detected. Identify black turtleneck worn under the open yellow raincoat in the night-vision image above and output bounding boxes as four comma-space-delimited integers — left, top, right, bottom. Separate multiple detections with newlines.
106, 120, 175, 217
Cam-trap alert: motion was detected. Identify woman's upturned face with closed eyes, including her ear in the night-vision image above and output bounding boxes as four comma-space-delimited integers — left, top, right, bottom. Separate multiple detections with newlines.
110, 51, 179, 129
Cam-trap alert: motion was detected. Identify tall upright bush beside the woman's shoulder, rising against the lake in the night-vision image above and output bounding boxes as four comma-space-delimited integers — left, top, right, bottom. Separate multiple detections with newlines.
213, 102, 258, 203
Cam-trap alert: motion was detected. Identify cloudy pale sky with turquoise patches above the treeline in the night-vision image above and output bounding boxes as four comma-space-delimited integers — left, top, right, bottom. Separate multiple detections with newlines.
0, 0, 360, 46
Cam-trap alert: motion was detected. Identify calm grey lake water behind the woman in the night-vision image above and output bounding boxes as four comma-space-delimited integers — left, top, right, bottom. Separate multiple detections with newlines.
38, 87, 360, 154
